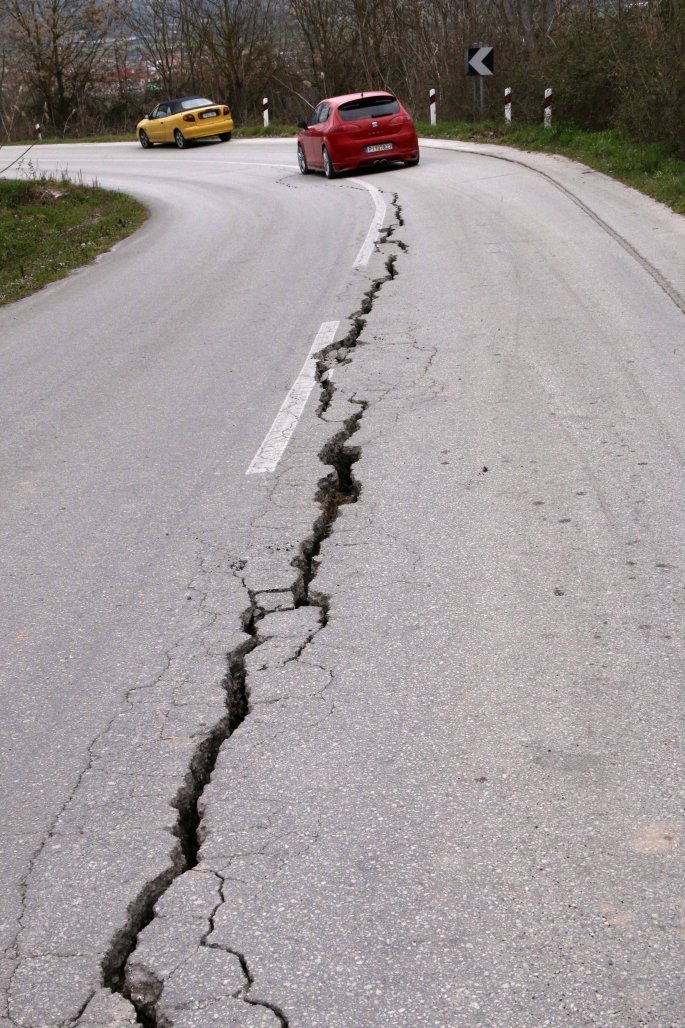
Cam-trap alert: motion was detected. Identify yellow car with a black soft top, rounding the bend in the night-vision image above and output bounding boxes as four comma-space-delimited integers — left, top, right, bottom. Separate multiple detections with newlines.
136, 97, 233, 150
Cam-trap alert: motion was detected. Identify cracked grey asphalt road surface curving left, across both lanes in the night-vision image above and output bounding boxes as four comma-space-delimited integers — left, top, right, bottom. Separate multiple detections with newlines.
0, 141, 685, 1028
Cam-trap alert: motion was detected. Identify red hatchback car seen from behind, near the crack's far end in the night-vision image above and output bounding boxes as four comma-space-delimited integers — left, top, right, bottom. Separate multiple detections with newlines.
297, 91, 419, 179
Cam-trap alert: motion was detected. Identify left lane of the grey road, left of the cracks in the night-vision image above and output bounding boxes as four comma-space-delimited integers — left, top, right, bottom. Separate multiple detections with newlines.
0, 144, 384, 1019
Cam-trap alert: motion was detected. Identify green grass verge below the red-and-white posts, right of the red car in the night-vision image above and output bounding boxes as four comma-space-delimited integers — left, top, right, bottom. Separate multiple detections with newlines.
417, 122, 685, 214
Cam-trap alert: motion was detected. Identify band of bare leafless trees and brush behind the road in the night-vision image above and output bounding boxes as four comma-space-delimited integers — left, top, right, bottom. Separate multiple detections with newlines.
0, 0, 685, 152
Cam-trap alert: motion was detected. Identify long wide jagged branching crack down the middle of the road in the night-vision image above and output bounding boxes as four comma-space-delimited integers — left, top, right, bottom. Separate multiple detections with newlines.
102, 194, 407, 1028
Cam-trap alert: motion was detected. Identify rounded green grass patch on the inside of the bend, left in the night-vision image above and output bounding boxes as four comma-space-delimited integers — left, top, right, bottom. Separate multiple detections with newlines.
0, 177, 147, 304
